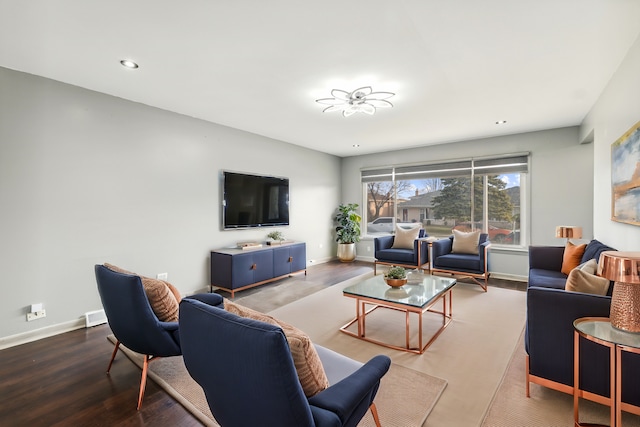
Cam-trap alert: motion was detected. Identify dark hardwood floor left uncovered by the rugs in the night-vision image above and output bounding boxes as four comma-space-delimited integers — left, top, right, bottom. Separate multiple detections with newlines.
0, 262, 523, 427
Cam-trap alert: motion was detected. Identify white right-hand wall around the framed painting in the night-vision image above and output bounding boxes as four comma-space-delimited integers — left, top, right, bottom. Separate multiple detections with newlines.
580, 34, 640, 251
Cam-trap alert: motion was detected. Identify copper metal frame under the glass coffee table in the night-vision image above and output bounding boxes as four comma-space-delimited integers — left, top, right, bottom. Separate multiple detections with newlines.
340, 289, 453, 354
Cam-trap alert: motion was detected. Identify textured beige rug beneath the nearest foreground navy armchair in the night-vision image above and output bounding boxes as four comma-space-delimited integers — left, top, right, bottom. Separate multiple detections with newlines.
109, 335, 447, 427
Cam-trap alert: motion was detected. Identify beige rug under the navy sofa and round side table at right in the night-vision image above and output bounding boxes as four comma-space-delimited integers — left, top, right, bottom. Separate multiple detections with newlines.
482, 333, 640, 427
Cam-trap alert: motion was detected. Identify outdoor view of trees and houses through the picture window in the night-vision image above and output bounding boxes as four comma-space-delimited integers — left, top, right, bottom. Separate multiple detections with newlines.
365, 173, 520, 244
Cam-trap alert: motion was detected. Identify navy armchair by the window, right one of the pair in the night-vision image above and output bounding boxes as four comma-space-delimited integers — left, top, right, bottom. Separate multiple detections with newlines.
431, 233, 491, 292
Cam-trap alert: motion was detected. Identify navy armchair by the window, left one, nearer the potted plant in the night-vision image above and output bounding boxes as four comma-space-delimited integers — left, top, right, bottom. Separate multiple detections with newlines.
373, 229, 429, 275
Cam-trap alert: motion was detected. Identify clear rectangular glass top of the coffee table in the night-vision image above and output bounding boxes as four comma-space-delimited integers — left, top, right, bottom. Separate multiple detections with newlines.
343, 271, 456, 308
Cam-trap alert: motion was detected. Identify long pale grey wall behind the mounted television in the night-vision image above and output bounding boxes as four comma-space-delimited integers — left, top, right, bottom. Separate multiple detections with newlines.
0, 68, 340, 345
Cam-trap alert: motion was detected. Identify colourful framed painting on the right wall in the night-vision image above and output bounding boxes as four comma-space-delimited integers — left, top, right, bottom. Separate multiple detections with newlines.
611, 122, 640, 225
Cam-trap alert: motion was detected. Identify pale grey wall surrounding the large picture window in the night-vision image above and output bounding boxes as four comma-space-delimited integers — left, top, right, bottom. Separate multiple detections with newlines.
342, 127, 593, 279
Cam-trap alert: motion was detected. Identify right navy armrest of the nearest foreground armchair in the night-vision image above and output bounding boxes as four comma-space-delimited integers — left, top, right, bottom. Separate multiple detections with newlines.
309, 355, 391, 422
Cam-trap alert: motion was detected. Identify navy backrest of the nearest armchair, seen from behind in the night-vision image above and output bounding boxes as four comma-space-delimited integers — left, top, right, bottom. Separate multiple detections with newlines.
180, 299, 314, 427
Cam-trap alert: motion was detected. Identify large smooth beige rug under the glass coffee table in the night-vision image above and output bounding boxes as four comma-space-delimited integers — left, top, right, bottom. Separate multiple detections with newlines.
270, 272, 526, 427
